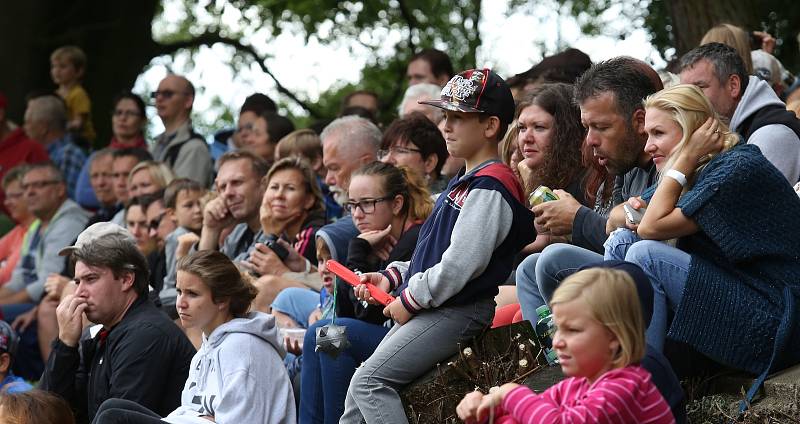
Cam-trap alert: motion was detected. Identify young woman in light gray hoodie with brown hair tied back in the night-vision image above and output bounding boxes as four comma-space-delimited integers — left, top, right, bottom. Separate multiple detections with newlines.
94, 250, 295, 424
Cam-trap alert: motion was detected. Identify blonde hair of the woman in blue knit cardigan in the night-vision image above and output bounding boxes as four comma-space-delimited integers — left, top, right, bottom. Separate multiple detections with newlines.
644, 84, 739, 189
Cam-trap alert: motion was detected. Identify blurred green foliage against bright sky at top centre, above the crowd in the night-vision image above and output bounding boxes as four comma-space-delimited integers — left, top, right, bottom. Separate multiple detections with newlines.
150, 0, 488, 126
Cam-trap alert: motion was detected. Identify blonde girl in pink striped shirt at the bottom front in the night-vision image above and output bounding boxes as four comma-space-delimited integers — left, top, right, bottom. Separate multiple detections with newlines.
456, 268, 675, 424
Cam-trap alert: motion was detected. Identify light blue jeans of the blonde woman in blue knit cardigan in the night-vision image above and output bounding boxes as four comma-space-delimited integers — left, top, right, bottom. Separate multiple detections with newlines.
604, 228, 692, 352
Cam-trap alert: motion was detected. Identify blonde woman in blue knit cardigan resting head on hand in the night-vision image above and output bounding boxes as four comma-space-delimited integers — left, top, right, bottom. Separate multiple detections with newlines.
606, 85, 800, 380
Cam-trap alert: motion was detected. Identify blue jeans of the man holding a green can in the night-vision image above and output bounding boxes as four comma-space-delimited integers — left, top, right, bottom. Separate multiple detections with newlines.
517, 243, 603, 323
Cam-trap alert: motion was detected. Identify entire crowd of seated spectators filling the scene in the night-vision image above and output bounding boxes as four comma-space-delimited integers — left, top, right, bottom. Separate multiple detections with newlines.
0, 24, 800, 424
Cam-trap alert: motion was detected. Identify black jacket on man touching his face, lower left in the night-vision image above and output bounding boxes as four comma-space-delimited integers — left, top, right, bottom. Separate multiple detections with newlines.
41, 299, 195, 423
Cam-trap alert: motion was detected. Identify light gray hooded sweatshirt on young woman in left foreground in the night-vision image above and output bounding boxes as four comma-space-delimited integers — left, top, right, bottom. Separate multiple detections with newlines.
164, 312, 297, 424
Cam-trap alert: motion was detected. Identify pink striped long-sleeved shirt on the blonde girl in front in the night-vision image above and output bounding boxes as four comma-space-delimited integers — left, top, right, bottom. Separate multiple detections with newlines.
496, 365, 675, 424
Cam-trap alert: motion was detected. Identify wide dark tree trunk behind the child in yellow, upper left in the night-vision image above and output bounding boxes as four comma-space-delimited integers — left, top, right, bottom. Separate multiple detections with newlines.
0, 0, 160, 146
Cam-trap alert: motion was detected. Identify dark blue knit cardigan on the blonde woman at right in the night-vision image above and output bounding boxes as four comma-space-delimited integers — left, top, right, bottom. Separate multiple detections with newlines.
647, 144, 800, 374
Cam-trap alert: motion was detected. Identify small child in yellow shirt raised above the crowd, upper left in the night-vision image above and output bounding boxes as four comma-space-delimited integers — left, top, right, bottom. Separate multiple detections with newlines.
50, 46, 95, 148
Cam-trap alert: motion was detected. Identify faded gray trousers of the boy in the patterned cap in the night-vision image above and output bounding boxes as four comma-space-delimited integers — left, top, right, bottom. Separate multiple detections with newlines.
339, 299, 495, 424
